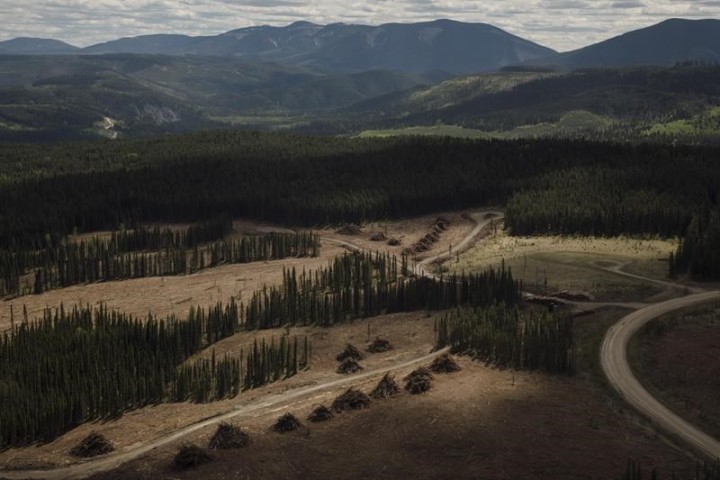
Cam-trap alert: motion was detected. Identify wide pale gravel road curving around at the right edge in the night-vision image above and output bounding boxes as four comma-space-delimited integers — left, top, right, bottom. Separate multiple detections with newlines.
600, 291, 720, 459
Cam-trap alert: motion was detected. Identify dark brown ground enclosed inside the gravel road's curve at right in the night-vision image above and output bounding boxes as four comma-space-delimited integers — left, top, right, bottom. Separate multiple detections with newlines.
629, 303, 720, 438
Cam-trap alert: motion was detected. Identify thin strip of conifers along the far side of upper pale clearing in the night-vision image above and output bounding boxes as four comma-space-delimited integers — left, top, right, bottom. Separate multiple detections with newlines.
0, 224, 319, 296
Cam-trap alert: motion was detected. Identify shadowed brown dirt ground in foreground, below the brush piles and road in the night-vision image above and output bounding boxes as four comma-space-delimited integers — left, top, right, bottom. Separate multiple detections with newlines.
93, 350, 691, 480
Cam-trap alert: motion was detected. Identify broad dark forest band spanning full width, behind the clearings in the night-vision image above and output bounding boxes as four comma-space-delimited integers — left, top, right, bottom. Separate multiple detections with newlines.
0, 132, 720, 249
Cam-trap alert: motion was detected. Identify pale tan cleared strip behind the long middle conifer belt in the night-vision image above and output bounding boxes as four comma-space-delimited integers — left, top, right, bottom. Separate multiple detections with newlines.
0, 214, 474, 332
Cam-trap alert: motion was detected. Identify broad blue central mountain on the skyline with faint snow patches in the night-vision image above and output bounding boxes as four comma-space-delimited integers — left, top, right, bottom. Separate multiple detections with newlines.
83, 20, 554, 74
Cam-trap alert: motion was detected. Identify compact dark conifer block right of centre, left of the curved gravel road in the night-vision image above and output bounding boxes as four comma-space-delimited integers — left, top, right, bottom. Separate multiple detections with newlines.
435, 304, 575, 374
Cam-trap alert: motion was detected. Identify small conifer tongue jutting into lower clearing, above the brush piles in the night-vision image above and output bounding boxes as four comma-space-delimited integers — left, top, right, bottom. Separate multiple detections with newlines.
170, 336, 311, 403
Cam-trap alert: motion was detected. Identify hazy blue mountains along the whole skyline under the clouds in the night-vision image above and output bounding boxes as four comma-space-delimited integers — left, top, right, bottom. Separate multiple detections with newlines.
0, 19, 720, 75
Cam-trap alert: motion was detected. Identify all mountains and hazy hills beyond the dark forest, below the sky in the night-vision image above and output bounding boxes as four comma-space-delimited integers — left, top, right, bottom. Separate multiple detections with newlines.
0, 20, 720, 141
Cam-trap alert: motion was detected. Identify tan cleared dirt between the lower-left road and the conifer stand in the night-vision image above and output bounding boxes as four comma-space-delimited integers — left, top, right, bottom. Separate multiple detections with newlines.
0, 314, 434, 470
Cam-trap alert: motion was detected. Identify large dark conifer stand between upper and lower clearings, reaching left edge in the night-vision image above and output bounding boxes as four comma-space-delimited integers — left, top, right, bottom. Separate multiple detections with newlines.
0, 254, 521, 448
